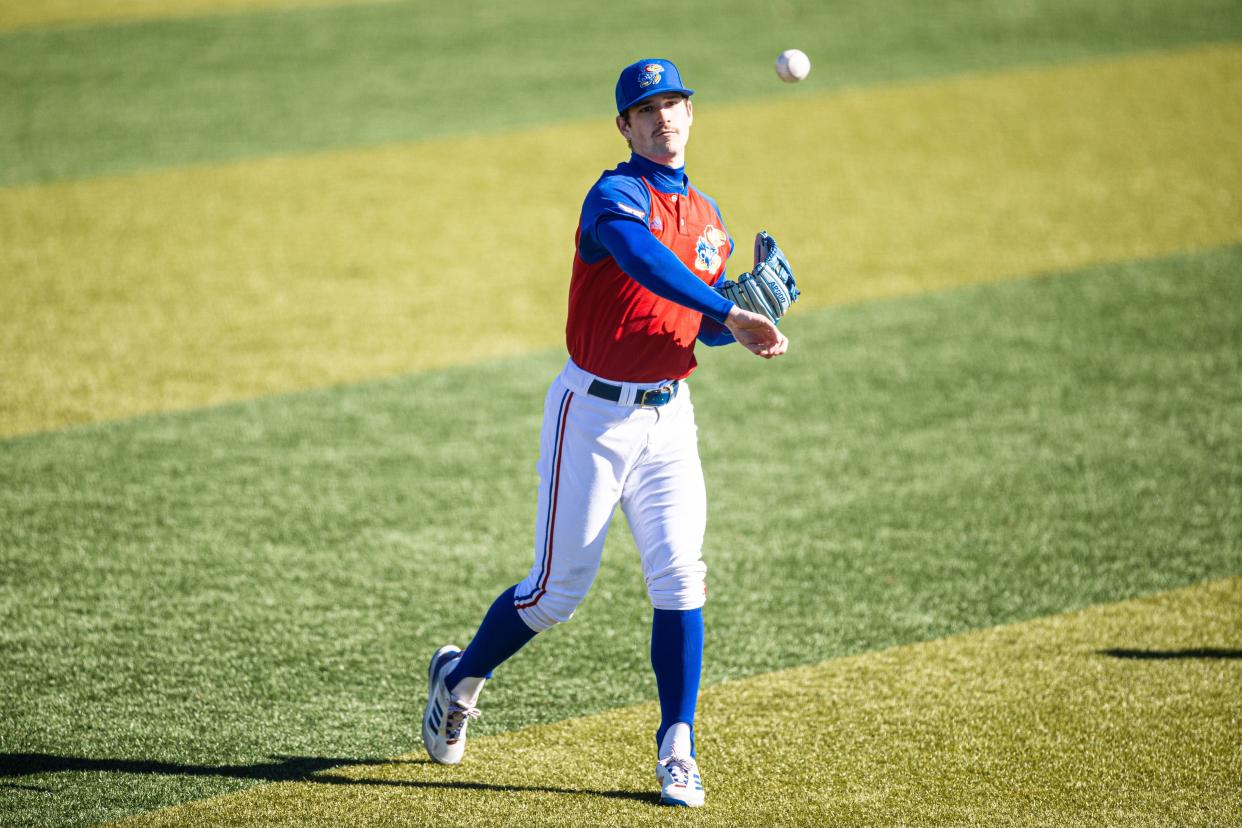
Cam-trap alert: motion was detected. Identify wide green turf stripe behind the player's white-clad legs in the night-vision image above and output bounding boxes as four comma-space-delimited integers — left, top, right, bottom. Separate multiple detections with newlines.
0, 247, 1242, 824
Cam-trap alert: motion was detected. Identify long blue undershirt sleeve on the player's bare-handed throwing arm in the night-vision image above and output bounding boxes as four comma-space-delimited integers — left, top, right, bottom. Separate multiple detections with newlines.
595, 217, 733, 323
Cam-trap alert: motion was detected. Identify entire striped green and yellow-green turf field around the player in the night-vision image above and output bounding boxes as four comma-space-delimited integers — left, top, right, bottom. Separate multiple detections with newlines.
0, 0, 1242, 826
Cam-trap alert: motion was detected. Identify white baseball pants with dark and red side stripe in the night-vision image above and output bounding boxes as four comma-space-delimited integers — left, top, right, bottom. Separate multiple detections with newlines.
514, 360, 707, 632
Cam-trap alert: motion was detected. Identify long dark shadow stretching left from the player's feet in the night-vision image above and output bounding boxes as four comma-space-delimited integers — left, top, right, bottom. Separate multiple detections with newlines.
0, 754, 658, 802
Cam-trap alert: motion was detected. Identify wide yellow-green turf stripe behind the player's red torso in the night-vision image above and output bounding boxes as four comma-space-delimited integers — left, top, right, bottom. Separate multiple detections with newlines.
0, 46, 1242, 436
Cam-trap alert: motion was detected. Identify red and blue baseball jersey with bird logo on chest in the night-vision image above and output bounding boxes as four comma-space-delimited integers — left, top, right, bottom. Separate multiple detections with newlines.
565, 155, 733, 382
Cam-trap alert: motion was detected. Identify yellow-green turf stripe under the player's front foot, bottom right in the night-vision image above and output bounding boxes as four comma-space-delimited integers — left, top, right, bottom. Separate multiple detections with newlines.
118, 578, 1242, 828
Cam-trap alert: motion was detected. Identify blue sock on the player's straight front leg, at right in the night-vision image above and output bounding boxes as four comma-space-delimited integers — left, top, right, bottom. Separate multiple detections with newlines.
651, 607, 703, 756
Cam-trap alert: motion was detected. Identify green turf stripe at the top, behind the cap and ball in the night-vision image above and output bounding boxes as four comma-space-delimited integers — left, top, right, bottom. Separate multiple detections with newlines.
7, 0, 1242, 185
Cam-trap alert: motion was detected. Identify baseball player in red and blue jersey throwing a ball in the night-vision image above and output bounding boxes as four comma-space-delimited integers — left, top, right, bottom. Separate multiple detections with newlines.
422, 58, 797, 807
